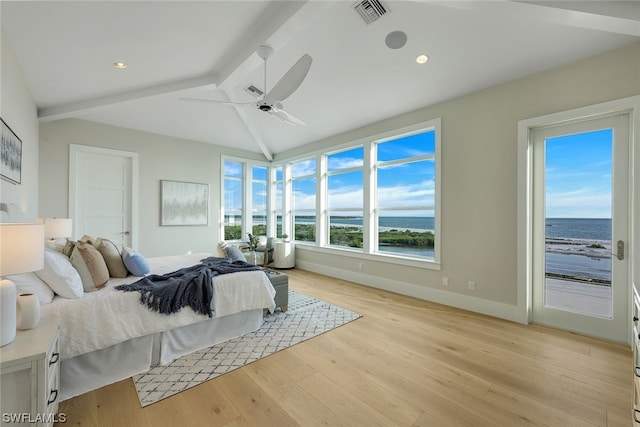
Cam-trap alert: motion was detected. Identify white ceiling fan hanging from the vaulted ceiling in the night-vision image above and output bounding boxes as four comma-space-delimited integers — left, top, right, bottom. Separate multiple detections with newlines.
180, 46, 313, 126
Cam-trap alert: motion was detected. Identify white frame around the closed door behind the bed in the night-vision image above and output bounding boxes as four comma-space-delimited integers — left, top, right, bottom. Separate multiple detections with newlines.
69, 144, 139, 248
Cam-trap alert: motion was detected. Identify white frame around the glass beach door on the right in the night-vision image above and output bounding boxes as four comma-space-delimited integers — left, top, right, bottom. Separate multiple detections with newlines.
517, 96, 640, 343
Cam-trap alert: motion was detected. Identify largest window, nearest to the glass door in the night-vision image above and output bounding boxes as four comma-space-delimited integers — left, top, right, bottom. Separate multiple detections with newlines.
374, 130, 436, 259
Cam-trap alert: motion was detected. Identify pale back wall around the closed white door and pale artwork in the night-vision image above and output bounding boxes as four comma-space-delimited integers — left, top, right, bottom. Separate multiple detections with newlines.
40, 119, 260, 256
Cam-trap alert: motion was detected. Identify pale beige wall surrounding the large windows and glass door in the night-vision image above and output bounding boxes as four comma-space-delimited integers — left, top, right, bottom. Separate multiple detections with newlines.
276, 43, 640, 320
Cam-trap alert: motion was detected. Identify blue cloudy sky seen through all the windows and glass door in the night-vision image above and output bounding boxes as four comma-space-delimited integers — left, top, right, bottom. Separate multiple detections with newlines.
230, 129, 612, 218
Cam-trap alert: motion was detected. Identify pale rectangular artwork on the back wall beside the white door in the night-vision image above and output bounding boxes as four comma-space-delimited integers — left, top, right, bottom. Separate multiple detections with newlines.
160, 180, 209, 225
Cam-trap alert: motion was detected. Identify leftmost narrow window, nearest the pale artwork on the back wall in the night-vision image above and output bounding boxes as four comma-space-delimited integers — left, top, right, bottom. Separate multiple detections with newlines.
223, 160, 244, 240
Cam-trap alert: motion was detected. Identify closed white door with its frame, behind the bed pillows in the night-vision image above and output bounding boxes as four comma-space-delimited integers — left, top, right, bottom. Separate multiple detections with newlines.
69, 145, 138, 248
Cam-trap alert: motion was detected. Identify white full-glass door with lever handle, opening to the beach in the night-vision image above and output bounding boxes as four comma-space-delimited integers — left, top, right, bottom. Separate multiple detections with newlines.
532, 114, 631, 342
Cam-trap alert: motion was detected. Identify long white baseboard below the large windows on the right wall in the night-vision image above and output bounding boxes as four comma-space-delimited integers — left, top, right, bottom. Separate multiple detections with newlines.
296, 260, 526, 323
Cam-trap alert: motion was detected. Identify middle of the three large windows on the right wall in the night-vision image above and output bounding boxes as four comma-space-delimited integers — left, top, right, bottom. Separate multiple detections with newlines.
327, 147, 364, 249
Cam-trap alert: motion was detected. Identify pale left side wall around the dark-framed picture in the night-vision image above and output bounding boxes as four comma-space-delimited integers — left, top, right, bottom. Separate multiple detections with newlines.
0, 31, 39, 222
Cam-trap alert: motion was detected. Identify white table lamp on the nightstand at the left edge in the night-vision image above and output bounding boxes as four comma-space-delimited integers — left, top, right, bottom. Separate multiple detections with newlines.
0, 223, 45, 347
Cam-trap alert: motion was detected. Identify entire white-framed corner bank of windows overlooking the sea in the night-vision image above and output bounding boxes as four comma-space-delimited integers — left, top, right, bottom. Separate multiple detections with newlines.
223, 119, 440, 268
